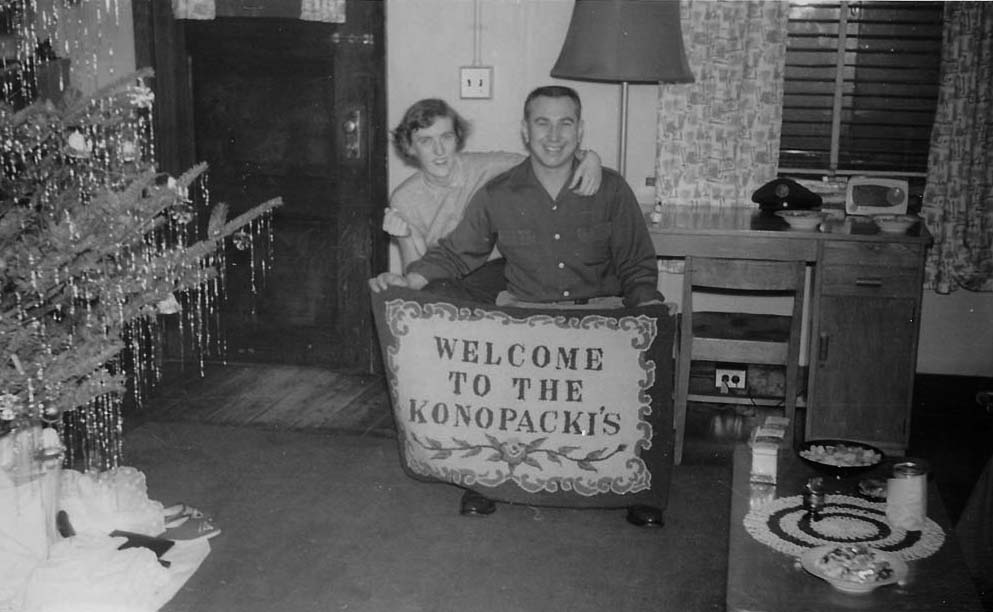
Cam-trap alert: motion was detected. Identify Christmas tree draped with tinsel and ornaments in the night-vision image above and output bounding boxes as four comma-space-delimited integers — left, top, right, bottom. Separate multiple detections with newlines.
0, 70, 281, 467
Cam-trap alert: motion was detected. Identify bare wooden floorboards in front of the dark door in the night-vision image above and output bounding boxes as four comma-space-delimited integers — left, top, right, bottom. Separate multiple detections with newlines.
138, 363, 394, 436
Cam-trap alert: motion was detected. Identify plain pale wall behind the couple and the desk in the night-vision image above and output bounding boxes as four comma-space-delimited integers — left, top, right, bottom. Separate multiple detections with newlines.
386, 0, 993, 377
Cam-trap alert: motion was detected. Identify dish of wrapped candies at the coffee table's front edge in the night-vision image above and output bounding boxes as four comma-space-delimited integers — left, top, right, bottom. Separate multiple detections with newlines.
800, 544, 907, 595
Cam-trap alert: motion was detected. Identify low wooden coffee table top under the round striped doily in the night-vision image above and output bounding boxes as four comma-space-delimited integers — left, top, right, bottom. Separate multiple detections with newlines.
727, 444, 983, 612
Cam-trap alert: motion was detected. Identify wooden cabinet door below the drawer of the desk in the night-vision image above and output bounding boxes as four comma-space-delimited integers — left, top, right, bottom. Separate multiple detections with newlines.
807, 295, 918, 450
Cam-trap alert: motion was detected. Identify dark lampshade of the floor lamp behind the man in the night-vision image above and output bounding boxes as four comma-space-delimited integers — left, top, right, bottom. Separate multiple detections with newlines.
552, 0, 693, 83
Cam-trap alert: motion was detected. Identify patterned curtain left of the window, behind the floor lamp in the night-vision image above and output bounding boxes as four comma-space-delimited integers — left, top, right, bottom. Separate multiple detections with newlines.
655, 0, 789, 207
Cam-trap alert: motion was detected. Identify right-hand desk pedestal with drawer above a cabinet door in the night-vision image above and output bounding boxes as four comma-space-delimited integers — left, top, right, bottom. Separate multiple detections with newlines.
806, 235, 926, 453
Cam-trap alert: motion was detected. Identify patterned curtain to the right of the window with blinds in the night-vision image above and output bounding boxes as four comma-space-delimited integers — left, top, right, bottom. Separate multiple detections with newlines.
923, 2, 993, 293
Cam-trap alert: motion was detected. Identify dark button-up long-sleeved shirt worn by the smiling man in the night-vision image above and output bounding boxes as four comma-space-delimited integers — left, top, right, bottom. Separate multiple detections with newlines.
407, 158, 658, 305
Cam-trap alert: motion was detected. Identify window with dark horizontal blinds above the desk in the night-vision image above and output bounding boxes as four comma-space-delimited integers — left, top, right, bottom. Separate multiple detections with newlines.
779, 0, 943, 177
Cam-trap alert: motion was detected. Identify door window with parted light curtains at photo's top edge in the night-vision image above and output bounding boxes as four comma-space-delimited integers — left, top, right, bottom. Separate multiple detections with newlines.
169, 0, 345, 23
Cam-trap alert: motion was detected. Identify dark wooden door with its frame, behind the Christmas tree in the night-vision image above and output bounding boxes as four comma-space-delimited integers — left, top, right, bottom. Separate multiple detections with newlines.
134, 0, 388, 371
